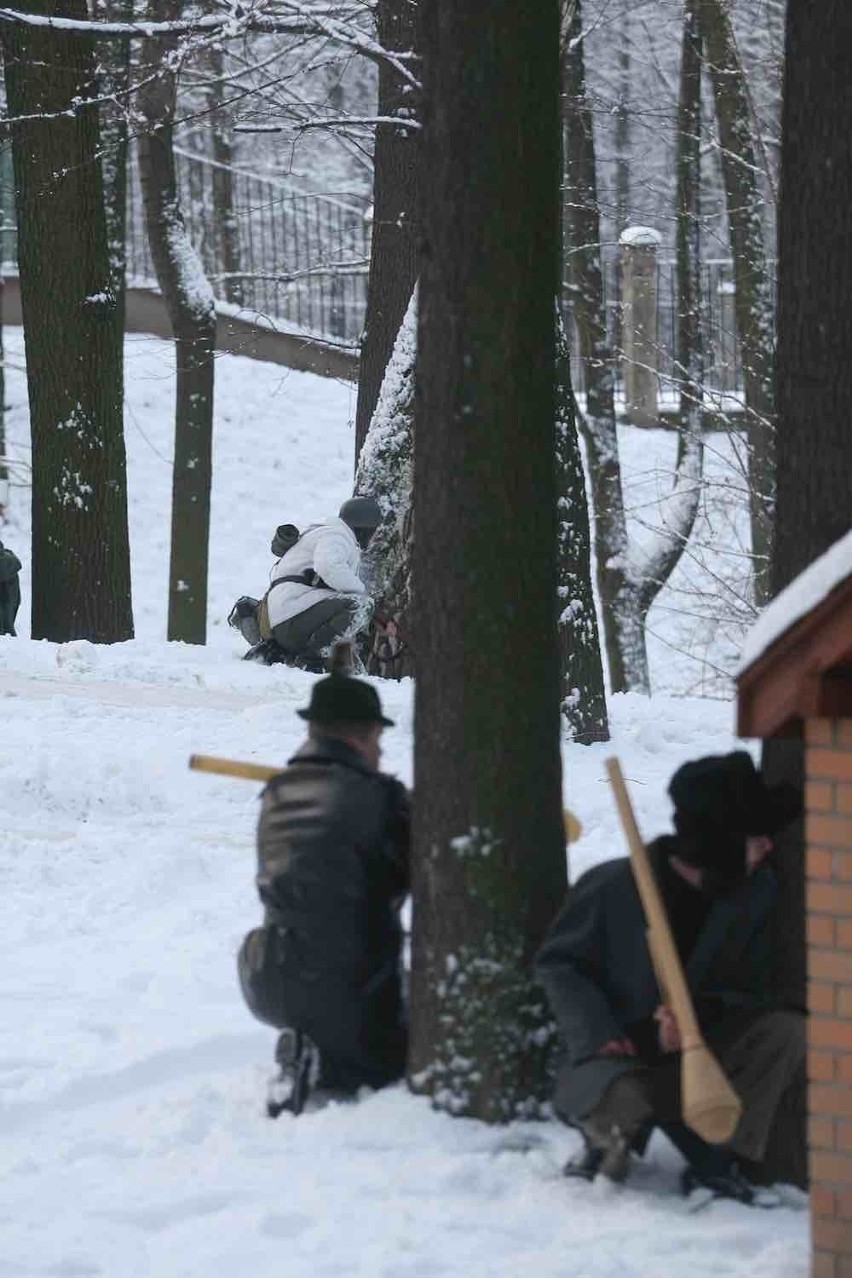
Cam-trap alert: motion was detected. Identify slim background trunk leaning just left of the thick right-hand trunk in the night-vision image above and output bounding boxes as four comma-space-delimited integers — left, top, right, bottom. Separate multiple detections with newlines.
696, 0, 775, 604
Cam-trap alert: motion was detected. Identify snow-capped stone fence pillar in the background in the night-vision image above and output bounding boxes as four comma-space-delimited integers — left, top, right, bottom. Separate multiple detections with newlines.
618, 226, 662, 426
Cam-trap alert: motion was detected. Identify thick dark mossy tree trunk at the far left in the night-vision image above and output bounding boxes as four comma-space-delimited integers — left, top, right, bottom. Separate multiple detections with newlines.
4, 0, 133, 643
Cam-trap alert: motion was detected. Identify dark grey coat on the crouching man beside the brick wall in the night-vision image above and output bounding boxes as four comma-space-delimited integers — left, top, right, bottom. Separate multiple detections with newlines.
535, 837, 775, 1120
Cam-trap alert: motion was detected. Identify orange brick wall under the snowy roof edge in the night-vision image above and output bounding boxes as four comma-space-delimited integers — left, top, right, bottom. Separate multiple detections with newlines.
805, 720, 852, 1278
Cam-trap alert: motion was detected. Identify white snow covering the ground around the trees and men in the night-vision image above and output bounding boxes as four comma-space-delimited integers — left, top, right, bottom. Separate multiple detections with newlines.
0, 334, 809, 1278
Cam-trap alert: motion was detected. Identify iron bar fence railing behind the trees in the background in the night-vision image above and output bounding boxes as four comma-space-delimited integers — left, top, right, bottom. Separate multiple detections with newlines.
0, 135, 771, 400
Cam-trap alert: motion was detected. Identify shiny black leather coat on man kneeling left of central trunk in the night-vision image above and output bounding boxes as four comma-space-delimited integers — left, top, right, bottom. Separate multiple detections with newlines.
257, 737, 409, 989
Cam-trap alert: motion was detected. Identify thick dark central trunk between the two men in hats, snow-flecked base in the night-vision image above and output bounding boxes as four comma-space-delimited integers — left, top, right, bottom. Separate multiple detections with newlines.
410, 0, 565, 1122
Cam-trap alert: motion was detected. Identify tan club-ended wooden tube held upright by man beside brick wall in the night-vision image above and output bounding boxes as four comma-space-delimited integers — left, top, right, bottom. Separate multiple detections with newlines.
607, 759, 742, 1145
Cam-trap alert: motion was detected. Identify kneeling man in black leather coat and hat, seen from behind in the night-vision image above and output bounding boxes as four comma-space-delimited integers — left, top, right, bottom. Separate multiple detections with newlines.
239, 674, 410, 1117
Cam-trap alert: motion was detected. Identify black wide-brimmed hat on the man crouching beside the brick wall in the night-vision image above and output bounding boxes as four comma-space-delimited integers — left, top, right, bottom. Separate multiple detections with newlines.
668, 750, 802, 836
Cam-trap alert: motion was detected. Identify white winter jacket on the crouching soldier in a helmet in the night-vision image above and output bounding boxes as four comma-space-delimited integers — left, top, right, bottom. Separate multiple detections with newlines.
267, 518, 367, 629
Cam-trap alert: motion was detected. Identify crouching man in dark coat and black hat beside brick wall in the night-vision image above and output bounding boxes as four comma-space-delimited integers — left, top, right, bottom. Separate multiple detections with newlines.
536, 750, 805, 1203
